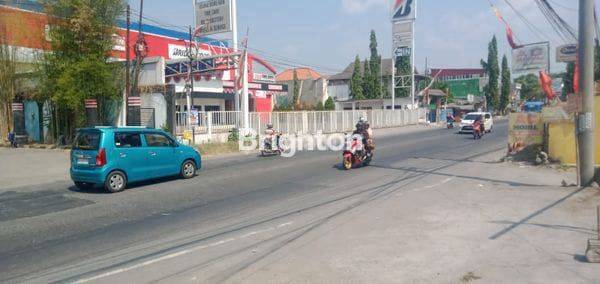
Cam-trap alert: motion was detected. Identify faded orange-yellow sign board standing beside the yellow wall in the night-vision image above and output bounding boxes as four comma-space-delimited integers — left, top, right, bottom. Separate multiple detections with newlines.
508, 112, 544, 154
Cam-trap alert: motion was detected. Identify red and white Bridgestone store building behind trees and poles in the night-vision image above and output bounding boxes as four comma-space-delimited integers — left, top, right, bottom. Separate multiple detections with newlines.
0, 0, 287, 140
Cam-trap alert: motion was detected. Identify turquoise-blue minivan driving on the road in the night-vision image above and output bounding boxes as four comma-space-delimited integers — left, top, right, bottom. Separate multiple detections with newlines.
71, 127, 202, 192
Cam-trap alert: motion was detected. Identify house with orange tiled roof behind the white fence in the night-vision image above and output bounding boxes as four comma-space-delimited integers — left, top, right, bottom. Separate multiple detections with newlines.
275, 67, 329, 107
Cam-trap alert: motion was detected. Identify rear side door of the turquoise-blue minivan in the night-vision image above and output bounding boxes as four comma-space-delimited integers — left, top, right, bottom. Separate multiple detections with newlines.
114, 132, 151, 181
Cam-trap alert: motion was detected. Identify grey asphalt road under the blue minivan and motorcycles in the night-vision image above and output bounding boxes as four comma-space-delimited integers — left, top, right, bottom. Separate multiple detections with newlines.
0, 121, 507, 283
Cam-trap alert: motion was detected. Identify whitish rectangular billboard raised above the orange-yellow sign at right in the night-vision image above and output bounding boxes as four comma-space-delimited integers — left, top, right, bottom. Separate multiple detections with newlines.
512, 42, 550, 73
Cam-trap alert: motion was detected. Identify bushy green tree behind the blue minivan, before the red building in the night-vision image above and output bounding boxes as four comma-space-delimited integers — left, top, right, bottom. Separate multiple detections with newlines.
39, 0, 124, 136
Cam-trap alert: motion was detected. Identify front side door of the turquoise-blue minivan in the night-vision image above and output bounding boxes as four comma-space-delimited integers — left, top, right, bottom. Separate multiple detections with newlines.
144, 132, 180, 177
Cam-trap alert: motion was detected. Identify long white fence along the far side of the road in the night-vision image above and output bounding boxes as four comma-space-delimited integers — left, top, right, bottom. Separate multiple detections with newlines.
177, 109, 425, 138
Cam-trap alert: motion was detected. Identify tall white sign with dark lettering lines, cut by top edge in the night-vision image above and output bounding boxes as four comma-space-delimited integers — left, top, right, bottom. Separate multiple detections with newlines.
195, 0, 231, 35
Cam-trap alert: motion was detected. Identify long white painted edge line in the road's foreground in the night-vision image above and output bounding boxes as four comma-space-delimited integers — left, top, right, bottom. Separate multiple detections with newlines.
73, 222, 293, 284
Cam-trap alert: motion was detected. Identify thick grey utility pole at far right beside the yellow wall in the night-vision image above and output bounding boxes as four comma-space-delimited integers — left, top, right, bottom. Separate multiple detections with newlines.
577, 0, 595, 186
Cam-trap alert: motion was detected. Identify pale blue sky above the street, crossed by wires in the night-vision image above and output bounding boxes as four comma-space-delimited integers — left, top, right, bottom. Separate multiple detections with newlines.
129, 0, 600, 74
